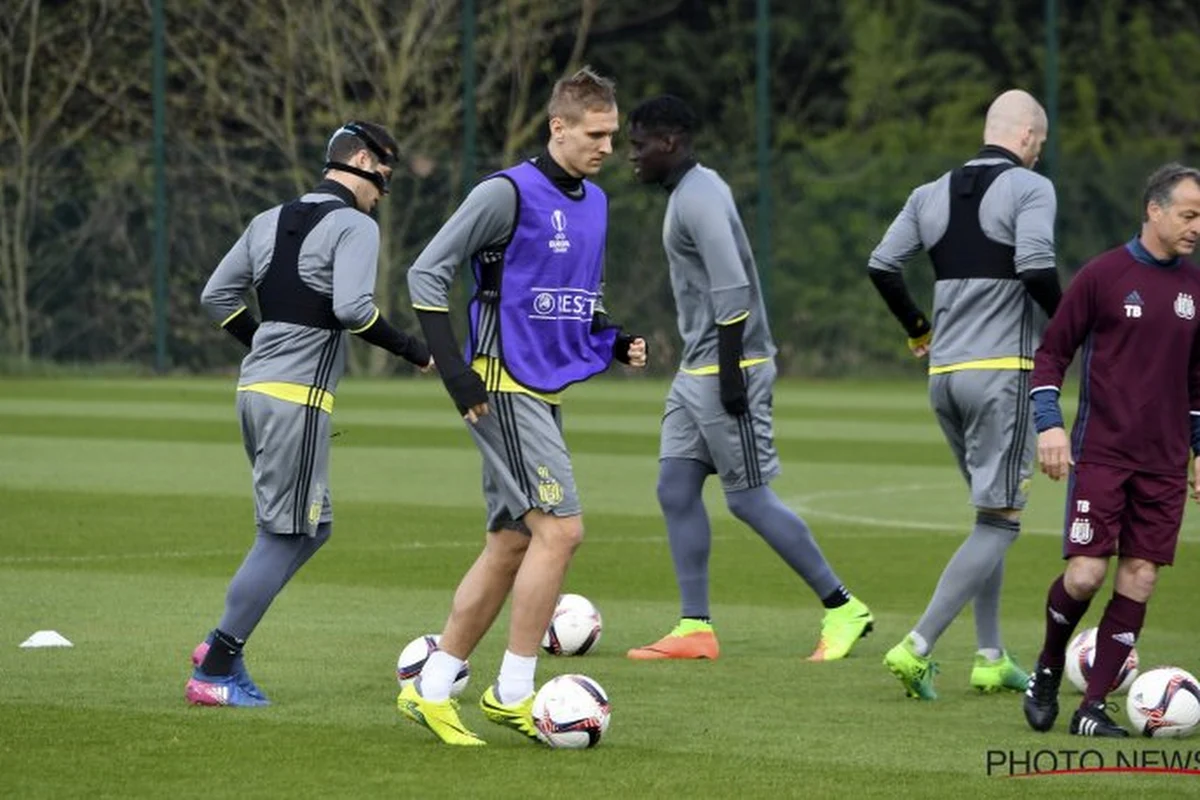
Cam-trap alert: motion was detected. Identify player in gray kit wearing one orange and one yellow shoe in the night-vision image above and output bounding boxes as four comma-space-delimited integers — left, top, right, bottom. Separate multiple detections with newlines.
628, 95, 874, 661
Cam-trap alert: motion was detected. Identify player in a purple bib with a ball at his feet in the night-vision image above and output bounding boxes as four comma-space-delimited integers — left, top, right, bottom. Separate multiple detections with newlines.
397, 68, 646, 746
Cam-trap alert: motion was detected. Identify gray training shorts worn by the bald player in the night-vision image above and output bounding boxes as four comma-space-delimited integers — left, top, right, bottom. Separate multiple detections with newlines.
929, 369, 1037, 509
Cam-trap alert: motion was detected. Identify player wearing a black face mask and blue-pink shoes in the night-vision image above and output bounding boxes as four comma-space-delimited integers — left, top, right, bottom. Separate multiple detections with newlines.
186, 122, 432, 706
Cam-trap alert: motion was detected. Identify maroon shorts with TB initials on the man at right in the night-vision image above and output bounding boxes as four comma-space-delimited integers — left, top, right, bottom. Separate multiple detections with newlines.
1062, 464, 1188, 565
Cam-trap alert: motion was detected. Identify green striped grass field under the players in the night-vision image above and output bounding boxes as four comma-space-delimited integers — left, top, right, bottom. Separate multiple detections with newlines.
0, 379, 1200, 799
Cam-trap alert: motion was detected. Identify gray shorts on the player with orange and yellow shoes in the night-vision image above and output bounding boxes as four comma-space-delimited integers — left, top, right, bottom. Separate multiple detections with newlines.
659, 361, 779, 492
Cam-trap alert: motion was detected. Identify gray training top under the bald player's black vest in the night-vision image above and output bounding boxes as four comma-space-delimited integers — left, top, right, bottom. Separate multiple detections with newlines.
868, 157, 1056, 372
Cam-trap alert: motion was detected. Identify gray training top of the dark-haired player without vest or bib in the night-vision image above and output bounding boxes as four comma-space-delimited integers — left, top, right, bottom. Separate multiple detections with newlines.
662, 164, 775, 372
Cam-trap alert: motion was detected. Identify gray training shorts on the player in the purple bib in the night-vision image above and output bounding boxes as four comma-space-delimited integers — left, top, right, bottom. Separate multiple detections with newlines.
467, 392, 583, 533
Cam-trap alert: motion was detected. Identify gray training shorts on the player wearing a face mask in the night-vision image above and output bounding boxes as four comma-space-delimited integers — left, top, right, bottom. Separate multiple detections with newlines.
238, 391, 334, 536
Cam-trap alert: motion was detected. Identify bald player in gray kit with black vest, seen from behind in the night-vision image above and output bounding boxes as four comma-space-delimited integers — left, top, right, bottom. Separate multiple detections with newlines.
868, 90, 1062, 700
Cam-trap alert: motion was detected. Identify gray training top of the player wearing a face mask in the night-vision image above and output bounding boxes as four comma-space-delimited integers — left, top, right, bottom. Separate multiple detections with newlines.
200, 192, 379, 402
